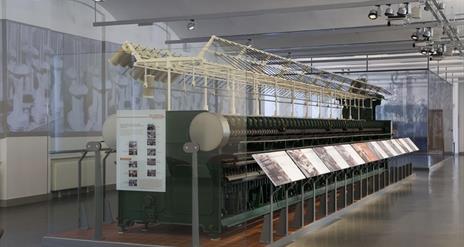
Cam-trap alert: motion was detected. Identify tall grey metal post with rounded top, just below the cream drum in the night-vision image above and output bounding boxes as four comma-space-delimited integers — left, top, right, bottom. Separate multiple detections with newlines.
184, 143, 200, 247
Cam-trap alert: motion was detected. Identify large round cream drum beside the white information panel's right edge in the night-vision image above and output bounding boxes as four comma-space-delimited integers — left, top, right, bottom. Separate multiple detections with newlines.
189, 112, 230, 152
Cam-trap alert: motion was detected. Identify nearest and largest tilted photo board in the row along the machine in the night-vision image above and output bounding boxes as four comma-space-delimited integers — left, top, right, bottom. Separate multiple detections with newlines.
253, 151, 305, 186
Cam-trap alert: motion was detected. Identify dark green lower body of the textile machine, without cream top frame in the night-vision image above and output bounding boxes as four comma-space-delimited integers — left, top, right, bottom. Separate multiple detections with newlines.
118, 111, 391, 237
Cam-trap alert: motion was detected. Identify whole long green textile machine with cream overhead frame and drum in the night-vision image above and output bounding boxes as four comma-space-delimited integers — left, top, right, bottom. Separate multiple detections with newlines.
110, 36, 406, 237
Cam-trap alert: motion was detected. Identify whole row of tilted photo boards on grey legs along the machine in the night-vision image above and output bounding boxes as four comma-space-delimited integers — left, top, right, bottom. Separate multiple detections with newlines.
253, 138, 417, 243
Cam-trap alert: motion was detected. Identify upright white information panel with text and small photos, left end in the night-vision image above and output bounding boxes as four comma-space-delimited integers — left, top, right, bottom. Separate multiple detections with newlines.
116, 110, 166, 192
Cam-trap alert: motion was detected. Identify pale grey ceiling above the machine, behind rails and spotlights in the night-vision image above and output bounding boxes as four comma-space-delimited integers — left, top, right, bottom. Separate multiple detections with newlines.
101, 0, 464, 81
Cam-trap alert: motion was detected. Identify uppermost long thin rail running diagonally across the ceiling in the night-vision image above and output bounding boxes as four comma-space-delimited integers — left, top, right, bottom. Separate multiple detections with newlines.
93, 0, 419, 27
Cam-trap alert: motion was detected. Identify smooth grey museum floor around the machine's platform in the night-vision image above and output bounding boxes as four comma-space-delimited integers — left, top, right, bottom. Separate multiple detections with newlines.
0, 156, 464, 247
